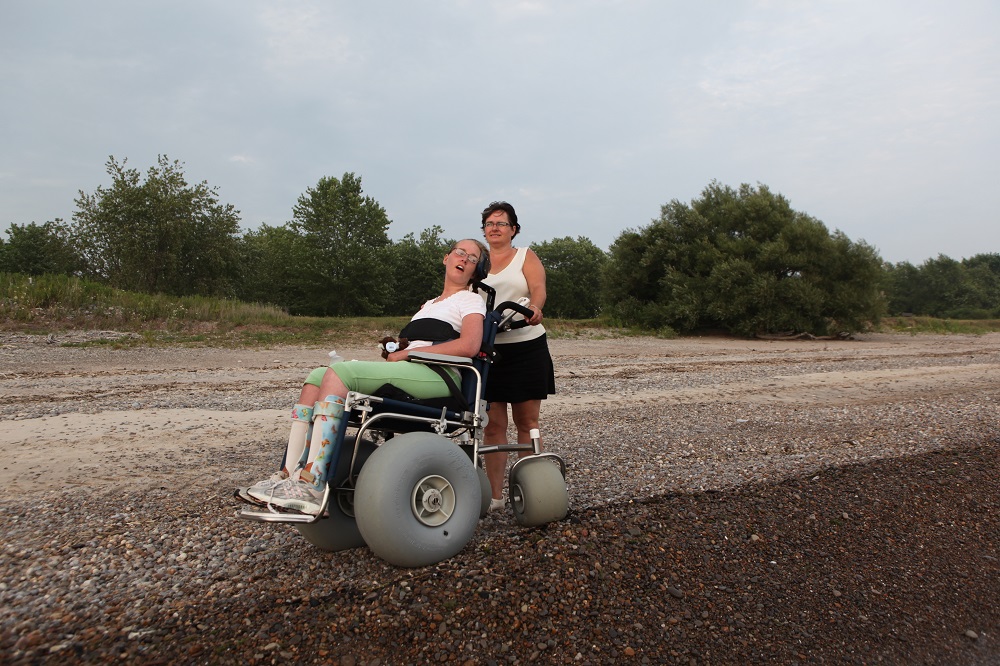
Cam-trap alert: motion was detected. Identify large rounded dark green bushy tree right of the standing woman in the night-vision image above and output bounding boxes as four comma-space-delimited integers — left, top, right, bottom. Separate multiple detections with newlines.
603, 182, 884, 335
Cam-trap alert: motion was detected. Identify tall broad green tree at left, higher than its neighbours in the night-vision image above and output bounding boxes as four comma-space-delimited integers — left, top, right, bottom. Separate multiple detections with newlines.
73, 155, 239, 296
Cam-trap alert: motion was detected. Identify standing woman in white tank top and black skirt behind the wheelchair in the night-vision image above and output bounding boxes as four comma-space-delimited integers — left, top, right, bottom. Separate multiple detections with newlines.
483, 201, 556, 511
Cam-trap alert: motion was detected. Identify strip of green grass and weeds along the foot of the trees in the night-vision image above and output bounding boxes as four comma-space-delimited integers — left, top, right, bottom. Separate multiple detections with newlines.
7, 273, 1000, 348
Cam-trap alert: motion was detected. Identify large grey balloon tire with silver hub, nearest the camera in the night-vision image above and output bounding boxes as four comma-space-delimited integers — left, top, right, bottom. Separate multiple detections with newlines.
354, 432, 482, 567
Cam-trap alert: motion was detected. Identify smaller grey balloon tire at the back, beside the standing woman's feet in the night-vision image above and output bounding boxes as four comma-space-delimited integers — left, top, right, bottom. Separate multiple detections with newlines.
510, 458, 569, 527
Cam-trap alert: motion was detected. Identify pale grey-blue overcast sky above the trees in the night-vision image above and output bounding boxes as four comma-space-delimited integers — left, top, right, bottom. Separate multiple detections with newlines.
0, 0, 1000, 265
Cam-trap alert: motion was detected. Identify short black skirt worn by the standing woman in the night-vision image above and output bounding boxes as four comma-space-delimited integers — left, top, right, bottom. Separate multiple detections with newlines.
486, 334, 556, 403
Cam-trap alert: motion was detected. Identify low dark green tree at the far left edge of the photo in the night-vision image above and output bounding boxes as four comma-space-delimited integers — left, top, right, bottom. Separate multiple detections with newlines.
0, 218, 80, 275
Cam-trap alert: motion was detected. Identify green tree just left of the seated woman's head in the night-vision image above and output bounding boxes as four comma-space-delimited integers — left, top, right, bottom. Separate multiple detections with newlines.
386, 225, 454, 316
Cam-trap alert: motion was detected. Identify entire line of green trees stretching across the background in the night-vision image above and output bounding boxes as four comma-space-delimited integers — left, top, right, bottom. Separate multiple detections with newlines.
0, 156, 1000, 335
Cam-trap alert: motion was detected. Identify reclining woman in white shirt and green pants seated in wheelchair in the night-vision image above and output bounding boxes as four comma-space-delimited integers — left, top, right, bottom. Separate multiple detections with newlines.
247, 239, 489, 515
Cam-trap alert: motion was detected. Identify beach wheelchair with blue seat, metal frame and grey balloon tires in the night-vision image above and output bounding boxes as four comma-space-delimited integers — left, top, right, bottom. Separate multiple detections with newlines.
230, 281, 569, 567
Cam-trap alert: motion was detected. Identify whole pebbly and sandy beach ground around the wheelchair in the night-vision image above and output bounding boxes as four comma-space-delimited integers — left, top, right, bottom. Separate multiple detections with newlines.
0, 333, 1000, 666
